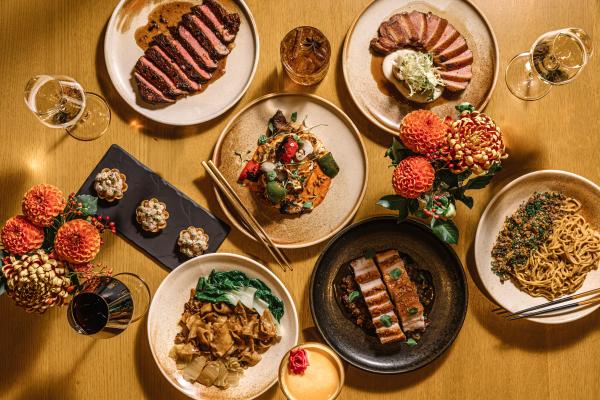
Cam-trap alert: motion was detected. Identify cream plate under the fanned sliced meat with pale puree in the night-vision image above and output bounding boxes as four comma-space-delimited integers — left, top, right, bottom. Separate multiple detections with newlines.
342, 0, 499, 135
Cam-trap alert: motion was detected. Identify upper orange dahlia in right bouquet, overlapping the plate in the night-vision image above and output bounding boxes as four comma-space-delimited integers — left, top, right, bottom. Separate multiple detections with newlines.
400, 110, 447, 156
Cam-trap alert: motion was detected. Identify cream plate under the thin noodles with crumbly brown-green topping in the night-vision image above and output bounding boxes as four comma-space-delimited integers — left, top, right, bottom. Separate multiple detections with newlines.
474, 170, 600, 324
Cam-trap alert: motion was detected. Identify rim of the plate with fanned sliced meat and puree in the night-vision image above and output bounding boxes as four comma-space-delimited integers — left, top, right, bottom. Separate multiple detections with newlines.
342, 0, 500, 136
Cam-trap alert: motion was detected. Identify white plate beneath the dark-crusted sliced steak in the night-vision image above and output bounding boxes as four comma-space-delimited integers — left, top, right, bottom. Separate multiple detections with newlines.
104, 0, 259, 125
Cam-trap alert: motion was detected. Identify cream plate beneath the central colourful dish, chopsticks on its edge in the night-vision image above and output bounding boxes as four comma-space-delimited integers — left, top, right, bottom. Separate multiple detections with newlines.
213, 93, 367, 248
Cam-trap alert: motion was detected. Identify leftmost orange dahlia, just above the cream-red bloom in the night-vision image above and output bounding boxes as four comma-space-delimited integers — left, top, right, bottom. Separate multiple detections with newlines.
0, 215, 44, 255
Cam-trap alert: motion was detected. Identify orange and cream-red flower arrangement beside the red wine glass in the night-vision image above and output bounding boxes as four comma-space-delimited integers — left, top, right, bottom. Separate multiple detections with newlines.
0, 184, 116, 313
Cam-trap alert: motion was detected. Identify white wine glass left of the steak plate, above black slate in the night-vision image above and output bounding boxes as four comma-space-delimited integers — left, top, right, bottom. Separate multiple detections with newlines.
25, 75, 110, 140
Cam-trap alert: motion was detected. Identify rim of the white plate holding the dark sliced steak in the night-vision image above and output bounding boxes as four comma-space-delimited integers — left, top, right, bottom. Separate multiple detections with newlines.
103, 0, 260, 126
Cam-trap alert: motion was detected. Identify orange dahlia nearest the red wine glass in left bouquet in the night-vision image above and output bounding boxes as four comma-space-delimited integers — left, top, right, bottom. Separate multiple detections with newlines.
54, 219, 101, 264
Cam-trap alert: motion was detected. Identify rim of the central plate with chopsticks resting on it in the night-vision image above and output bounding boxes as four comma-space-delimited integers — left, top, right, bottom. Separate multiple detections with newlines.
211, 91, 369, 249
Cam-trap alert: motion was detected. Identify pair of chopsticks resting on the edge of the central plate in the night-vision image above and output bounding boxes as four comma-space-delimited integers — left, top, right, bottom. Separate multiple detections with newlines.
202, 160, 293, 271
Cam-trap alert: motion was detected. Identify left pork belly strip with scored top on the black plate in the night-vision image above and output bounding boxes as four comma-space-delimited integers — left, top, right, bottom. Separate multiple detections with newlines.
350, 257, 406, 344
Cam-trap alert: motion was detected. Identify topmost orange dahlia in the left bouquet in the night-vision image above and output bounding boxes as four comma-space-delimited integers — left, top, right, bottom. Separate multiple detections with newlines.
21, 184, 67, 227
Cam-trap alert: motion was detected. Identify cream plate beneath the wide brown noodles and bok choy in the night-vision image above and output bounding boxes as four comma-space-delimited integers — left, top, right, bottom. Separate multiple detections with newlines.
148, 253, 299, 400
